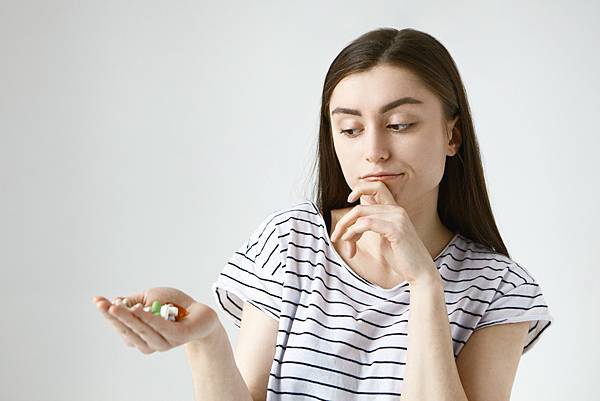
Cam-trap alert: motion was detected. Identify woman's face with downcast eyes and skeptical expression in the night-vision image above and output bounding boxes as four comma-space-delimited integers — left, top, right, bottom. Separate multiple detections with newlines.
329, 65, 460, 207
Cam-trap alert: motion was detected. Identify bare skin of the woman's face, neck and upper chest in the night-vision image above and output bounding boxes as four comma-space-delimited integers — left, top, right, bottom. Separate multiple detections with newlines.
330, 65, 461, 288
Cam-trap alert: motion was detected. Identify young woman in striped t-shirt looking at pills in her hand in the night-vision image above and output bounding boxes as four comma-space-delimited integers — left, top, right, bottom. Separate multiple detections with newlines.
95, 28, 553, 401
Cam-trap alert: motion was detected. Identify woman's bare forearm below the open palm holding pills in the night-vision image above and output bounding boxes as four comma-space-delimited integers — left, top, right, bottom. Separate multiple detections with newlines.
185, 310, 253, 401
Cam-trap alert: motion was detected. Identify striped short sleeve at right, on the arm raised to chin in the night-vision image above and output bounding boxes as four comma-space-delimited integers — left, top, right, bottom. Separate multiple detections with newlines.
475, 263, 554, 354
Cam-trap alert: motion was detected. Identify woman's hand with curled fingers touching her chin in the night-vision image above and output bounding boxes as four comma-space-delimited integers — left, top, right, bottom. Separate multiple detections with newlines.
331, 181, 440, 285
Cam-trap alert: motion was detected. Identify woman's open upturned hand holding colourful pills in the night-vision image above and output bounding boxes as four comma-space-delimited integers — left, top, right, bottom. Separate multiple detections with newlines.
93, 287, 219, 354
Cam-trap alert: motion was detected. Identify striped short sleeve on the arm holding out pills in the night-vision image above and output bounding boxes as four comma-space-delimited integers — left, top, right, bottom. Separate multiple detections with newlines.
212, 212, 285, 327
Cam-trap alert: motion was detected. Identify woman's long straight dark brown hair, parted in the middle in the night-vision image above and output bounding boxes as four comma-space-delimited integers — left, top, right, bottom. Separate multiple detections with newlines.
313, 28, 510, 258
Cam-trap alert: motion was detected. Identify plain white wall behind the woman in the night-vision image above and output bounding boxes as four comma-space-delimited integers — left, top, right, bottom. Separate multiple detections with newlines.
0, 0, 600, 401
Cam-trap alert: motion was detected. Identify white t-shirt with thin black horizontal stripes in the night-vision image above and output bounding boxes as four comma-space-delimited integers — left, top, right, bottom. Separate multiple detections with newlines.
212, 200, 553, 401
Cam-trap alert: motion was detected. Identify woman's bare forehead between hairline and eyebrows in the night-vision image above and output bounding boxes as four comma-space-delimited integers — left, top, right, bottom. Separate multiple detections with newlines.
329, 65, 435, 113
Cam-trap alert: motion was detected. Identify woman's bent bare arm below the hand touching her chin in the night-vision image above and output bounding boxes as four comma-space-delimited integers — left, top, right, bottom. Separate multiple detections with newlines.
401, 275, 529, 401
